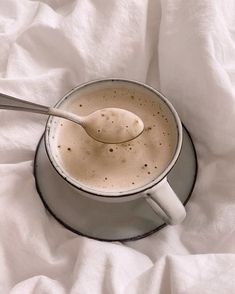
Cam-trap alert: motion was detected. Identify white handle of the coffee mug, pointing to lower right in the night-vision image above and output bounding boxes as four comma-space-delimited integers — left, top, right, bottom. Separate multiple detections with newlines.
144, 178, 186, 225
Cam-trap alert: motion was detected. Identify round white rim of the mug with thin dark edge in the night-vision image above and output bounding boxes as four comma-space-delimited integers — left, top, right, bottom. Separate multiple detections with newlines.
44, 78, 183, 199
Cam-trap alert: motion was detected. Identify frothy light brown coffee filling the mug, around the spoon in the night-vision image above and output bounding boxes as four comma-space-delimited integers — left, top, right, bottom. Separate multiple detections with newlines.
55, 85, 177, 193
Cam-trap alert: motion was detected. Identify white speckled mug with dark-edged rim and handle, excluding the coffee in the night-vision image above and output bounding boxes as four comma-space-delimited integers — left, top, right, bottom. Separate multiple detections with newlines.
44, 79, 186, 225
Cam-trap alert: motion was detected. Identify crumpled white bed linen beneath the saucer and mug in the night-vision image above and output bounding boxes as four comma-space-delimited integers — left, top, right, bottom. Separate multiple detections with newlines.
0, 0, 235, 294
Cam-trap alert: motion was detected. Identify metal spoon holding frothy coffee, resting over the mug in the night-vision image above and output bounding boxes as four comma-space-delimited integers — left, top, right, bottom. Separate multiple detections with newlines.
0, 93, 144, 144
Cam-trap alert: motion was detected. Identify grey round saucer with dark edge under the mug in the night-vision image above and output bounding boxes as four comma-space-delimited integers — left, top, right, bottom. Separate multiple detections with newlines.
34, 127, 197, 241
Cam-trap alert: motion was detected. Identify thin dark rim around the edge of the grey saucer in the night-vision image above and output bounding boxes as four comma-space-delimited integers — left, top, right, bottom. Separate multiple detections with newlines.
33, 125, 198, 242
